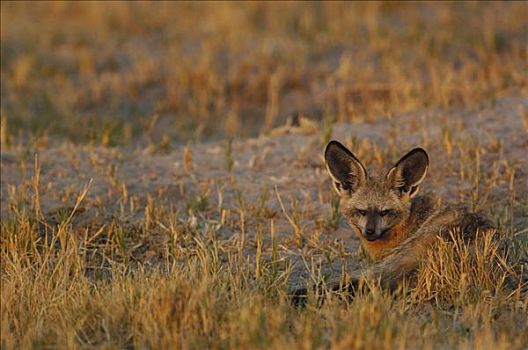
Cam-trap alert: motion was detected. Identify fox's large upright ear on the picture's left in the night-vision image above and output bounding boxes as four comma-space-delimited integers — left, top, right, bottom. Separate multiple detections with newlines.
325, 141, 367, 196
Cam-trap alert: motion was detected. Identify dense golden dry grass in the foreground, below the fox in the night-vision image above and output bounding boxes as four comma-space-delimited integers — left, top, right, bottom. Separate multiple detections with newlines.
1, 213, 528, 349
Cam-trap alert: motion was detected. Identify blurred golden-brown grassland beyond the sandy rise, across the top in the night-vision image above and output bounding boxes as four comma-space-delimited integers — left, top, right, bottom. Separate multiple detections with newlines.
1, 2, 528, 147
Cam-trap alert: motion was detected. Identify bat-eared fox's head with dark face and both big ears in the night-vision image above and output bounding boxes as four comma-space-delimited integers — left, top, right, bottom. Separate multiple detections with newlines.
325, 141, 429, 244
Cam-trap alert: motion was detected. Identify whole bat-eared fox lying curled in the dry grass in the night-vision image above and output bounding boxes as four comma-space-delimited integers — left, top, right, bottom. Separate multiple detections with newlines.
325, 141, 493, 286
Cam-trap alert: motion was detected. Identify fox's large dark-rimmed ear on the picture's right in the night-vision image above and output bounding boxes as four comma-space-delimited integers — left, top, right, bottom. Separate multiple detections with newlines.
387, 148, 429, 198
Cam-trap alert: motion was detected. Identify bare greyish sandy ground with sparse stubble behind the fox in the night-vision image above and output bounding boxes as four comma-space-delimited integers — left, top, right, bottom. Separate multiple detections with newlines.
1, 96, 528, 284
